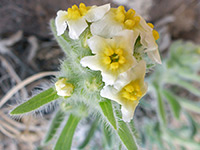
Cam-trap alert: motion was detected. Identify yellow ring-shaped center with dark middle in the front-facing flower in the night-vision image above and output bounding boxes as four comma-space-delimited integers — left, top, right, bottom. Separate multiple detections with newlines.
103, 48, 126, 70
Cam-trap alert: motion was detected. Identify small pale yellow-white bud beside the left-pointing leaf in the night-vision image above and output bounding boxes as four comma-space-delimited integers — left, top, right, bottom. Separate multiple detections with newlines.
55, 78, 74, 96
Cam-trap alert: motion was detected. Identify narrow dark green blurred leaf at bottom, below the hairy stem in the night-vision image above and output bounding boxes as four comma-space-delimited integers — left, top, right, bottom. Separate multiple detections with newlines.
79, 119, 99, 149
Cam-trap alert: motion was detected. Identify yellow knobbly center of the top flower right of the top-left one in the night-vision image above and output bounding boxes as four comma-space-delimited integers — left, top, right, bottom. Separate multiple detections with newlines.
115, 6, 140, 29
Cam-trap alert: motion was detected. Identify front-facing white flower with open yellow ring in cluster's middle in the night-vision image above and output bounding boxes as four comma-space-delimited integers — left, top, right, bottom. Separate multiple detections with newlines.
80, 30, 137, 85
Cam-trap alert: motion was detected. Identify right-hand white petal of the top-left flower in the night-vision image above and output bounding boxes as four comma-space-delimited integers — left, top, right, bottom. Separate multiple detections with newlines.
85, 4, 110, 22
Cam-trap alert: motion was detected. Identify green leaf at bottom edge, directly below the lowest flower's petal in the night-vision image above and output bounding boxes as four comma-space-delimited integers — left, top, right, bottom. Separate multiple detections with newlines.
117, 121, 138, 150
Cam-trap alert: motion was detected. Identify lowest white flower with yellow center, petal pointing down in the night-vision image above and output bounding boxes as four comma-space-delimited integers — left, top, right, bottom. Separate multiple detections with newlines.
101, 60, 147, 122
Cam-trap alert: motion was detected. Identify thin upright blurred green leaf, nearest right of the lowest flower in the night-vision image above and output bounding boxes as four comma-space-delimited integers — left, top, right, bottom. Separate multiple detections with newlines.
154, 83, 167, 125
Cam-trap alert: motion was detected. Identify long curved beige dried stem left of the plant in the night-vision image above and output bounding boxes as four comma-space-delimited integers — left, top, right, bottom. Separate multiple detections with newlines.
0, 71, 58, 108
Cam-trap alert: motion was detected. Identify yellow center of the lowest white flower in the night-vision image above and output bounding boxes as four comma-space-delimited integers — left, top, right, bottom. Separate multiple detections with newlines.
120, 80, 142, 101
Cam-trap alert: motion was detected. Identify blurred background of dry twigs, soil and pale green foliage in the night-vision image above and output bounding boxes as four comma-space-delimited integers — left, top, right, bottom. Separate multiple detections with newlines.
0, 0, 200, 150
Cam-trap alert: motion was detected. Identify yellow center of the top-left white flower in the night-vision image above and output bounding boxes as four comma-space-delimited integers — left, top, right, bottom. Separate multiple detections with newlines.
67, 3, 90, 20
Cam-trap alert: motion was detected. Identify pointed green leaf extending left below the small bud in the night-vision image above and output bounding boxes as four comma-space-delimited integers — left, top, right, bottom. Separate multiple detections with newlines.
10, 88, 59, 115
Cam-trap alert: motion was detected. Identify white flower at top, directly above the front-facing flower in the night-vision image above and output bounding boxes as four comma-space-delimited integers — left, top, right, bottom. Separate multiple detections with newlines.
91, 6, 151, 37
